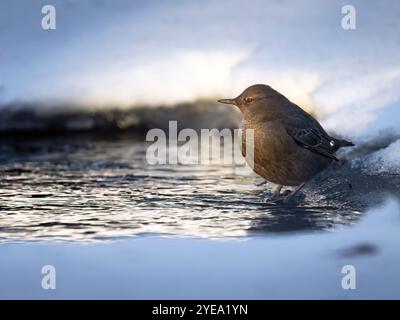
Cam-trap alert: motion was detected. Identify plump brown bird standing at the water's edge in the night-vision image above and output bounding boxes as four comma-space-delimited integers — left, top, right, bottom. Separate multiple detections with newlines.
218, 84, 354, 203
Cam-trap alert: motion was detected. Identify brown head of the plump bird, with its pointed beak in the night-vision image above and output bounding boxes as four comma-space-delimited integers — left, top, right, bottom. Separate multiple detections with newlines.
218, 84, 283, 113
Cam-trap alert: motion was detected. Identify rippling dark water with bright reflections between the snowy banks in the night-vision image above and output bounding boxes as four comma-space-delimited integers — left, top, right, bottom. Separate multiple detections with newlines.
0, 135, 376, 241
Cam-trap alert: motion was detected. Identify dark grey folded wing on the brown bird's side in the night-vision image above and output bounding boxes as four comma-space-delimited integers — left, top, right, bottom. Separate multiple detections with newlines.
284, 112, 339, 161
